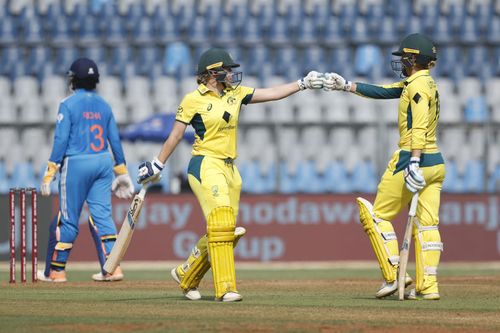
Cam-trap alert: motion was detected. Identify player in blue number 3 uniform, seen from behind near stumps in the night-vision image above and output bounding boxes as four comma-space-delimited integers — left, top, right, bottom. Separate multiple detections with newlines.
38, 58, 134, 282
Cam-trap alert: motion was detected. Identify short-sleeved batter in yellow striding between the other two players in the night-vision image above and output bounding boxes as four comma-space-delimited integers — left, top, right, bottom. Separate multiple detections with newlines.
138, 48, 324, 302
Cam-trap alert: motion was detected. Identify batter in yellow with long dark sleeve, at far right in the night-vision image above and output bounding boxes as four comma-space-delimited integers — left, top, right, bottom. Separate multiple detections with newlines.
324, 33, 445, 300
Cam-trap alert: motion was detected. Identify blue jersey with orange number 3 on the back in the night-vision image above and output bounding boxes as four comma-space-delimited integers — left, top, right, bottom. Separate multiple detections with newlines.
49, 89, 125, 165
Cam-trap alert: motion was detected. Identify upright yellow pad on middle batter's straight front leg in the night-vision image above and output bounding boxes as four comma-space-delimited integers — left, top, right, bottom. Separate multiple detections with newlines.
207, 206, 237, 298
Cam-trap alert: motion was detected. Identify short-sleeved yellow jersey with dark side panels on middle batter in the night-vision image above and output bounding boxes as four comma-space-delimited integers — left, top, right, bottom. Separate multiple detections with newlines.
175, 84, 254, 159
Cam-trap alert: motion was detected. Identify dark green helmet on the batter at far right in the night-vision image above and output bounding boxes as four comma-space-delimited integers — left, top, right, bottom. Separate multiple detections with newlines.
392, 33, 437, 65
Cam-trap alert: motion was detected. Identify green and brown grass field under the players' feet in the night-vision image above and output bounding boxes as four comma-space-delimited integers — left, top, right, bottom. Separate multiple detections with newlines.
0, 263, 500, 333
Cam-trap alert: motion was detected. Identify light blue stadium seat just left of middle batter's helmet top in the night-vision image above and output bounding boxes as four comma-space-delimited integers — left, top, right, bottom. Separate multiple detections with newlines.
163, 42, 194, 77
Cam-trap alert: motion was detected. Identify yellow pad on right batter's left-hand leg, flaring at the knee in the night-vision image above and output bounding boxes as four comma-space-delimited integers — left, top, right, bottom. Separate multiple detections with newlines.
356, 198, 399, 282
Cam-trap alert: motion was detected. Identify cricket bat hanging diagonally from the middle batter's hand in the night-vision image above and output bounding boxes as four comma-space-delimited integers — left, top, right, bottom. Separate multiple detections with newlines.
103, 184, 146, 273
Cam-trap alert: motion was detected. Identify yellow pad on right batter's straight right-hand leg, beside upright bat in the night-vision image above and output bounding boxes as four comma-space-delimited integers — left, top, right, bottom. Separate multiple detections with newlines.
413, 221, 443, 294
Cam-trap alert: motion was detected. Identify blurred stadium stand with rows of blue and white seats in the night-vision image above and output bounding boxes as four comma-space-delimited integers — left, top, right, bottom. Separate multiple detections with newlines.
0, 0, 500, 193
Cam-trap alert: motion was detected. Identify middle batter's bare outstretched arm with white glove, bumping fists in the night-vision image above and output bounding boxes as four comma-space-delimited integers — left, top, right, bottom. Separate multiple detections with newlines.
248, 71, 324, 104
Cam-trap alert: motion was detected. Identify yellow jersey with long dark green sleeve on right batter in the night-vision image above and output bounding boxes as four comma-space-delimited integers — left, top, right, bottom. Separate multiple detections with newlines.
356, 70, 439, 153
